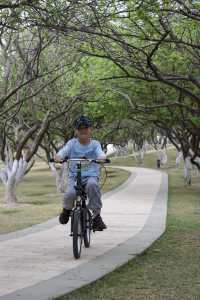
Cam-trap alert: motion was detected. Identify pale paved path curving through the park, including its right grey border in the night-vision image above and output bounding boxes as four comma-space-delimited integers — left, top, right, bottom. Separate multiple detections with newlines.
0, 167, 167, 300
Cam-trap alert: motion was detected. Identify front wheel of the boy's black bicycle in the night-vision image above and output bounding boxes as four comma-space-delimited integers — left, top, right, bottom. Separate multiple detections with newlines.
72, 211, 83, 259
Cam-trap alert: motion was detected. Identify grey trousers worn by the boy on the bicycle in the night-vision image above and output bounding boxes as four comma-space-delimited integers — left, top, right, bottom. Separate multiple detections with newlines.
63, 177, 102, 216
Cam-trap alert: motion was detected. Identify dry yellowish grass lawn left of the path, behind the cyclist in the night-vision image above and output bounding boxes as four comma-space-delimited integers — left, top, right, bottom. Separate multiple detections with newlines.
0, 163, 129, 234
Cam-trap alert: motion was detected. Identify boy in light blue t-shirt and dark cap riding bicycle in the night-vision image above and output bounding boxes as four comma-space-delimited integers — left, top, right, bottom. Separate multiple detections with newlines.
55, 116, 106, 231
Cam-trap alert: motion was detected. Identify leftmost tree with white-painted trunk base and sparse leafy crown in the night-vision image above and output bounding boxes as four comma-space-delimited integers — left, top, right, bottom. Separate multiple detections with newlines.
0, 24, 85, 206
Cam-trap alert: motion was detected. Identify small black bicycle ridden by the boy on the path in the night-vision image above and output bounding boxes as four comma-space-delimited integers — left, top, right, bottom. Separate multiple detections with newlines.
50, 158, 110, 259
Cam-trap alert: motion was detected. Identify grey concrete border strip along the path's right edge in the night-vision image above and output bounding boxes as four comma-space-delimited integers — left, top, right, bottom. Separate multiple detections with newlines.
0, 173, 168, 300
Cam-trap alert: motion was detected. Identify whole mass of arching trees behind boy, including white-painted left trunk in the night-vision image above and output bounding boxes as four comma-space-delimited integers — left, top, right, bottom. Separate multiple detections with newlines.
0, 0, 200, 203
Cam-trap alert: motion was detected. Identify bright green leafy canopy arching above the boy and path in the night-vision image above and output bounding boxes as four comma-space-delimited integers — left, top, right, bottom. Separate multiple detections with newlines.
0, 0, 200, 155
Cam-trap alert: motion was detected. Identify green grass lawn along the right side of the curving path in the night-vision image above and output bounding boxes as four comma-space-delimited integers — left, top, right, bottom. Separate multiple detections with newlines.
54, 151, 200, 300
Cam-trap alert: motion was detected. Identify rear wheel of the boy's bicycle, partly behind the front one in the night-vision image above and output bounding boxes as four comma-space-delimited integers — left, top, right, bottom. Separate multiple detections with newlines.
83, 208, 92, 248
